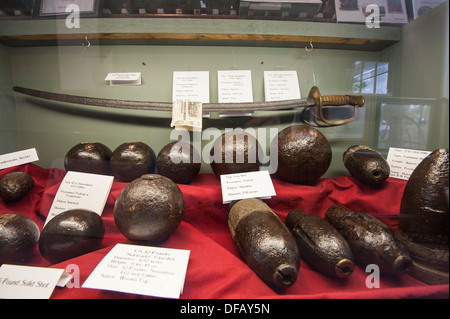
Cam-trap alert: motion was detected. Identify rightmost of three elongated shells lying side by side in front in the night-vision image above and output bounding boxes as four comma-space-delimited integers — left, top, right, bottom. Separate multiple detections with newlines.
325, 205, 412, 274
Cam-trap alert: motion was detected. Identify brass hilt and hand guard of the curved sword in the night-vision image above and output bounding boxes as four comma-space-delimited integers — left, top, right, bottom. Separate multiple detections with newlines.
301, 86, 365, 127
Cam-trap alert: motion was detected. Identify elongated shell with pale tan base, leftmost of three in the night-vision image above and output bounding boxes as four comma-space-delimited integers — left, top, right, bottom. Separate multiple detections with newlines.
228, 199, 300, 289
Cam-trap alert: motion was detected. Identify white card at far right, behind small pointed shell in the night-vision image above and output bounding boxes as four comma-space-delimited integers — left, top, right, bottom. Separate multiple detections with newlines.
387, 147, 431, 180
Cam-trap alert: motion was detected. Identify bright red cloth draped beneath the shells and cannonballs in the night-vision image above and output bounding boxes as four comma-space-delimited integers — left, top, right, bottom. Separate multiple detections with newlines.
0, 164, 449, 299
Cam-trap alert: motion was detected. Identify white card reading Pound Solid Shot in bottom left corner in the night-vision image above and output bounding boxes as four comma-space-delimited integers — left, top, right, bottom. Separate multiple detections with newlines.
0, 264, 72, 299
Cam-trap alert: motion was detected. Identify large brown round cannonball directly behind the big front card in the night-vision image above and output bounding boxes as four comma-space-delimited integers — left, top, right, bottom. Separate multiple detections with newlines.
114, 174, 185, 243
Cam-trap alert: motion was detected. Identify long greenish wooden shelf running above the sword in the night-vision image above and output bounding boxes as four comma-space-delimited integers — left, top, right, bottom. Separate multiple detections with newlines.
0, 18, 401, 51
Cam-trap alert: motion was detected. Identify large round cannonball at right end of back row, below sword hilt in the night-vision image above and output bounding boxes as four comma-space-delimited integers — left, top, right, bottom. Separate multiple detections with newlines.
272, 125, 332, 185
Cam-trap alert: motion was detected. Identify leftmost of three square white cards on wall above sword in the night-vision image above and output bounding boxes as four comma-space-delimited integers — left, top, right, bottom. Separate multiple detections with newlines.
172, 71, 209, 103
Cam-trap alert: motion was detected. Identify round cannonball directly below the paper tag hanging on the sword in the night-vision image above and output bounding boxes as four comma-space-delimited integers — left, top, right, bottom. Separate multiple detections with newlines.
156, 141, 202, 184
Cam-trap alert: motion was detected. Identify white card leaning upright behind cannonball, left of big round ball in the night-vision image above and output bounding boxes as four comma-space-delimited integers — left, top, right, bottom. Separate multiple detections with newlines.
45, 171, 114, 224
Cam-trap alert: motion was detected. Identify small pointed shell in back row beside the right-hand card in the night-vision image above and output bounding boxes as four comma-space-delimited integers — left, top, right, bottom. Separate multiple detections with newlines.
343, 145, 391, 187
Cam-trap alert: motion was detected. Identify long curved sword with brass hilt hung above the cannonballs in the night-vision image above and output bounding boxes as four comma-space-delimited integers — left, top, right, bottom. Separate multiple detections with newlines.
13, 86, 365, 126
